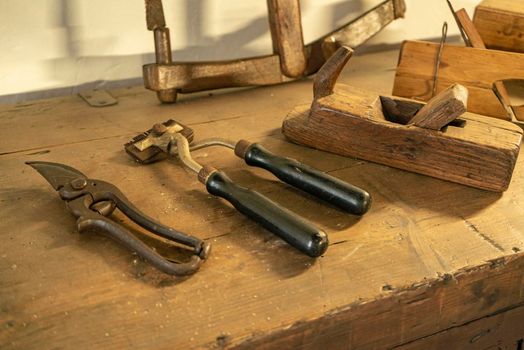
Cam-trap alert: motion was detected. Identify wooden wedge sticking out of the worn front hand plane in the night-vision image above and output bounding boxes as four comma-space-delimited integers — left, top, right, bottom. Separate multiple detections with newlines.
409, 84, 468, 130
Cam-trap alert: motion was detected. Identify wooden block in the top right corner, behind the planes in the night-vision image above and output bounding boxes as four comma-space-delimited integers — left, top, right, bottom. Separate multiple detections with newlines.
473, 0, 524, 52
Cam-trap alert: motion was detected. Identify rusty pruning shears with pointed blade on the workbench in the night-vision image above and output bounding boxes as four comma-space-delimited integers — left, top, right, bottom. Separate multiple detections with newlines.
26, 161, 210, 276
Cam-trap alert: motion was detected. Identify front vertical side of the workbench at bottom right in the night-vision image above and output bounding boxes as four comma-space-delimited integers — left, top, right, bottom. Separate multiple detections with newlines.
234, 254, 524, 350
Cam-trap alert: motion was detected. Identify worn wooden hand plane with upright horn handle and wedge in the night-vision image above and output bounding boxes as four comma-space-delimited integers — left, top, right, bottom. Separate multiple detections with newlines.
282, 47, 522, 192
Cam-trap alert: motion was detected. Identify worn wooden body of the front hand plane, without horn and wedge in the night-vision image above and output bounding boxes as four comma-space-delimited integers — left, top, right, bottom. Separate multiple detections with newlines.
282, 84, 522, 191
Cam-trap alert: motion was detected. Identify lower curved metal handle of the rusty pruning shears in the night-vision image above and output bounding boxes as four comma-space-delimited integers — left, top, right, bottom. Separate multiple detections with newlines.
68, 196, 204, 276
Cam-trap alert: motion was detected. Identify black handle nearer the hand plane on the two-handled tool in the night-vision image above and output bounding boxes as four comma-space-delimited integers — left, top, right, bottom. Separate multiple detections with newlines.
235, 140, 371, 215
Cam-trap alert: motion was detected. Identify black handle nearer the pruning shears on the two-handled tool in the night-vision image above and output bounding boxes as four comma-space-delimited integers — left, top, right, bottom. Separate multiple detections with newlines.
205, 170, 328, 257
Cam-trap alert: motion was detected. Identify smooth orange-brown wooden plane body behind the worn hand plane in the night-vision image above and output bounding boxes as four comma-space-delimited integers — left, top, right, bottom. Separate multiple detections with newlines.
393, 41, 524, 119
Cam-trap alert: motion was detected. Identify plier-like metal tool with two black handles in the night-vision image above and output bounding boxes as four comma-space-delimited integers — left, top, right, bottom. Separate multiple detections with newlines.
124, 120, 371, 257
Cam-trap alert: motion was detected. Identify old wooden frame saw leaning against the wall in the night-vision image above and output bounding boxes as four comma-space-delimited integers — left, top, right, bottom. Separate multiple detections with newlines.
143, 0, 406, 103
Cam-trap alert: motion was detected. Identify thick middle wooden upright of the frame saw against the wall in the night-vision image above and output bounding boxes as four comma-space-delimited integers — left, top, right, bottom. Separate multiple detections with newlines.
267, 0, 306, 78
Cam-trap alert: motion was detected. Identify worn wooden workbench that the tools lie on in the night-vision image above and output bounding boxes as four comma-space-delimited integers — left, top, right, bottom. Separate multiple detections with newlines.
0, 52, 524, 350
